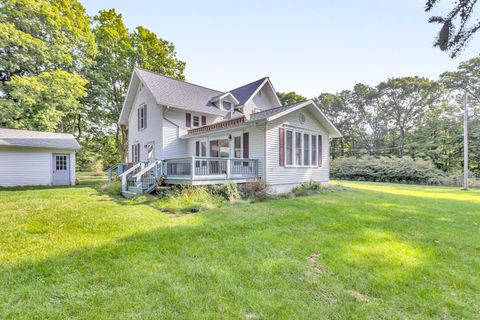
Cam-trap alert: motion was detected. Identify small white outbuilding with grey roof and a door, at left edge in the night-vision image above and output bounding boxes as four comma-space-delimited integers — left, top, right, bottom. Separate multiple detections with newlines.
0, 128, 80, 187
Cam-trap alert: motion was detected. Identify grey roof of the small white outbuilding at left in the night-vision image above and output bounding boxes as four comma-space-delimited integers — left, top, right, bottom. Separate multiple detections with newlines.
0, 128, 80, 150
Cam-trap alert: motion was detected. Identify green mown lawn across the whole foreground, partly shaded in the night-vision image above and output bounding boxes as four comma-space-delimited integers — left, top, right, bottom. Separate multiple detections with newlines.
0, 176, 480, 319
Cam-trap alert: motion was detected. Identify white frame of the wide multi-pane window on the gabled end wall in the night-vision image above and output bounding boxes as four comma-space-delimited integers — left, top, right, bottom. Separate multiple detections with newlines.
283, 127, 320, 168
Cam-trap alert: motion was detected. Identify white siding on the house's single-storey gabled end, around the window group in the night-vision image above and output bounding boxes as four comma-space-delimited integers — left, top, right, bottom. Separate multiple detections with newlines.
266, 109, 330, 192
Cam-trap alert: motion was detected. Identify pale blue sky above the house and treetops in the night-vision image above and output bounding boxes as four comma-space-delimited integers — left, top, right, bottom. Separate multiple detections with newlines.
80, 0, 480, 98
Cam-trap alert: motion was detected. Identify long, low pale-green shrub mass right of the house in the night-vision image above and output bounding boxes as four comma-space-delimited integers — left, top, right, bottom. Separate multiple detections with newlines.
331, 157, 446, 184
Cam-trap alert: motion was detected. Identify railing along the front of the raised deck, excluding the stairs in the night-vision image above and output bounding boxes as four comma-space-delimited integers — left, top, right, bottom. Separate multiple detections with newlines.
164, 157, 258, 180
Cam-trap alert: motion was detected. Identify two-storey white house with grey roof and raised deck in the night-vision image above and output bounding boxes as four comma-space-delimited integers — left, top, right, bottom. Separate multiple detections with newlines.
117, 69, 341, 193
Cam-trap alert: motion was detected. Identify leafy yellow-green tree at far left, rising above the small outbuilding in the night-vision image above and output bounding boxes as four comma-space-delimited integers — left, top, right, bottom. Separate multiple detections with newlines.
0, 0, 96, 132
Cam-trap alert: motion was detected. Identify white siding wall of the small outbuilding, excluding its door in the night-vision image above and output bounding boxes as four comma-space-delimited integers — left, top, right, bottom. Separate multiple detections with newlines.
0, 147, 76, 187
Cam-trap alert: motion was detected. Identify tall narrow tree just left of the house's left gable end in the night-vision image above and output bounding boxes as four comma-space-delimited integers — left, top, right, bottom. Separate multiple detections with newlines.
85, 9, 135, 164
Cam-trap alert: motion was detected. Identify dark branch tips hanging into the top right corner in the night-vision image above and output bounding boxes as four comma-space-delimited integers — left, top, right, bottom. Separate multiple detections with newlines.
425, 0, 480, 58
